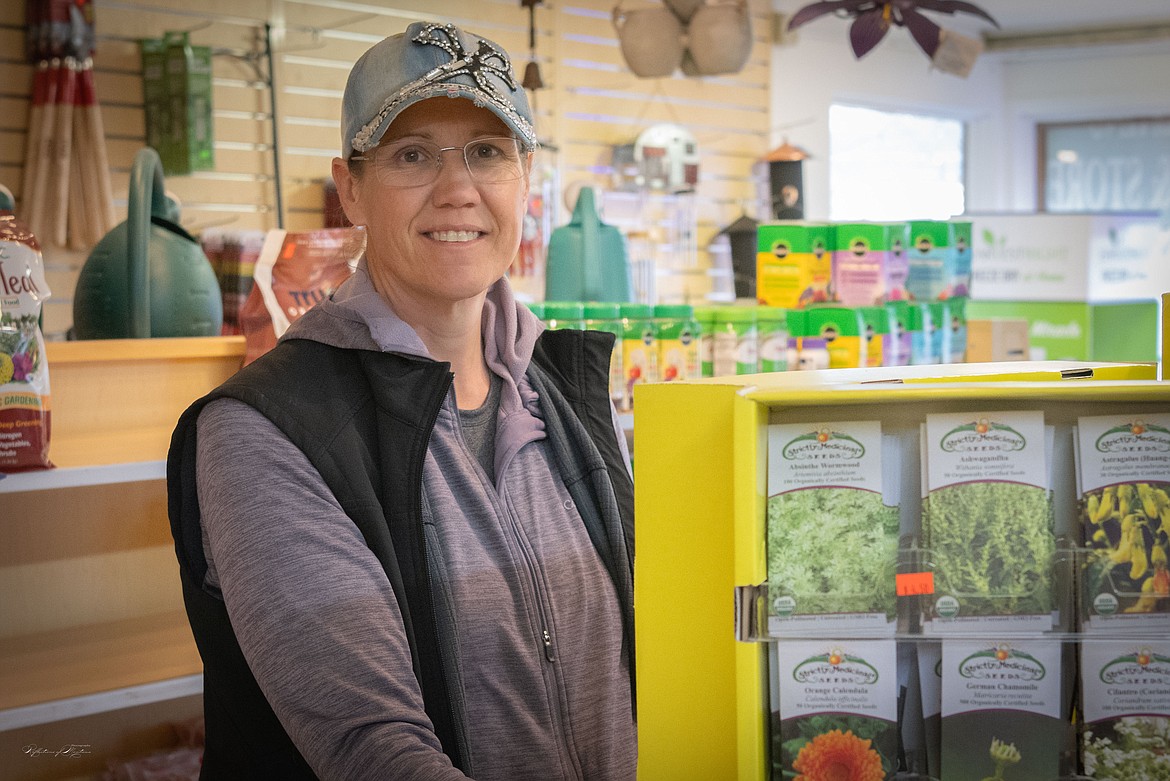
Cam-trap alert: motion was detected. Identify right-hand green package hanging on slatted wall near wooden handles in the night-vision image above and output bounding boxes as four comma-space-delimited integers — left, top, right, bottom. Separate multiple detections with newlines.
161, 33, 215, 174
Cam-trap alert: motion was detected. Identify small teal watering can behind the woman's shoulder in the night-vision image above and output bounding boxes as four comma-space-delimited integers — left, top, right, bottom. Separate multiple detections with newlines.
544, 187, 634, 302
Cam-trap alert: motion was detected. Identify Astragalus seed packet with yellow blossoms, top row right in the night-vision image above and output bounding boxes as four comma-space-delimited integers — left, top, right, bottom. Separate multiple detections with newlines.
1076, 414, 1170, 635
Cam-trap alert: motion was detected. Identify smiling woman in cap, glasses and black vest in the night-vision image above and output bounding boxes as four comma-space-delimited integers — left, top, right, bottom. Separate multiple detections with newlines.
168, 23, 636, 781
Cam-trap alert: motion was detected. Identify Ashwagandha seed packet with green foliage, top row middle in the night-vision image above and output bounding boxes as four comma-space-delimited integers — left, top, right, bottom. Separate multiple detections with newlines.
922, 412, 1055, 634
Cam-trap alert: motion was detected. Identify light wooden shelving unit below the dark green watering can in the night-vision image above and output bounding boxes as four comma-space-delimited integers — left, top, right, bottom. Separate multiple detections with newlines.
0, 337, 245, 777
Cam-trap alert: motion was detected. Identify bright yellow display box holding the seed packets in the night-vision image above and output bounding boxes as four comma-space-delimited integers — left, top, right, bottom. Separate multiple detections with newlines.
634, 362, 1170, 781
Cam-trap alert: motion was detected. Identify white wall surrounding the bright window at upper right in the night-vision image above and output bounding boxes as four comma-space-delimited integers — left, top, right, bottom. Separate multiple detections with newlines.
771, 0, 1170, 220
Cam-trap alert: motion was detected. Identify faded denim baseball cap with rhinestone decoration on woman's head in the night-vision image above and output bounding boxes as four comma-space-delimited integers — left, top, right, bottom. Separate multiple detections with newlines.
342, 22, 537, 158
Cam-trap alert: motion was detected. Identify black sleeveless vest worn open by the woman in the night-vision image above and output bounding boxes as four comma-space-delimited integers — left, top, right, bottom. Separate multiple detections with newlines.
167, 331, 633, 781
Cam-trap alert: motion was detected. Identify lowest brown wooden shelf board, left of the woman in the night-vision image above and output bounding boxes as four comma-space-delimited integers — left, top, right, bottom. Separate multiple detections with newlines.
0, 611, 202, 715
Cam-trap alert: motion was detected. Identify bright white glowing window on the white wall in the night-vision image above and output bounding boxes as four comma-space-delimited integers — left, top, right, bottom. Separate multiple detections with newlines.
828, 104, 964, 222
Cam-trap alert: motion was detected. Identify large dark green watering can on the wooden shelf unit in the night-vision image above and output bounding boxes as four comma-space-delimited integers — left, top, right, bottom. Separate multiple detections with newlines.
74, 146, 223, 339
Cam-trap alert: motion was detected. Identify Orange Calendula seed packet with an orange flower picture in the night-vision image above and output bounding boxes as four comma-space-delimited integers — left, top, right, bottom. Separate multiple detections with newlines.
772, 640, 897, 781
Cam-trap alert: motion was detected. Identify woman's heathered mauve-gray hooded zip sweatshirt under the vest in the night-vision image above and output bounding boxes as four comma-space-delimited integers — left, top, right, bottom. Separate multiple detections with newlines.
197, 265, 636, 781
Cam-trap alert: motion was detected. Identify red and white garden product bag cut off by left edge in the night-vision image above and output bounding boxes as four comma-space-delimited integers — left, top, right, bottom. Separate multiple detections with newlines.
0, 192, 53, 472
